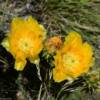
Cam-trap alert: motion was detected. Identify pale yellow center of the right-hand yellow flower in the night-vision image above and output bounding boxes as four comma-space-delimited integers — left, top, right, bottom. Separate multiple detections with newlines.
63, 53, 79, 68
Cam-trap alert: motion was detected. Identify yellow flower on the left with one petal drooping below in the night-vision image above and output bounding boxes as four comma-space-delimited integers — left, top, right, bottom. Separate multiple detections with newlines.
2, 16, 46, 71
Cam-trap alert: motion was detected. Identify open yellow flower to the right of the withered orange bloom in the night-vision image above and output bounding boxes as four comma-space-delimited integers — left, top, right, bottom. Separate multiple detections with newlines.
53, 32, 93, 82
